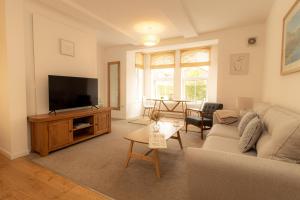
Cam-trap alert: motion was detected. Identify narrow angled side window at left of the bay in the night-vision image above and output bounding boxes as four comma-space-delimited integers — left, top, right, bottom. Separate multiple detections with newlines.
135, 53, 144, 102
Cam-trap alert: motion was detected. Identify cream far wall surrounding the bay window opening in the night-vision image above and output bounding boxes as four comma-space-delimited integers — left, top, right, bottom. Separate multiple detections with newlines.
102, 24, 265, 118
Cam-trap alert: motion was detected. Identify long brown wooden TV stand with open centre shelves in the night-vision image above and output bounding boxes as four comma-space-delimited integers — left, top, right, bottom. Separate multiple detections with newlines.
28, 107, 111, 156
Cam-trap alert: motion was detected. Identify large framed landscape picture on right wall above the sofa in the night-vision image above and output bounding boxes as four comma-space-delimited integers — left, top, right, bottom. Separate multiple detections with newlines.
281, 0, 300, 75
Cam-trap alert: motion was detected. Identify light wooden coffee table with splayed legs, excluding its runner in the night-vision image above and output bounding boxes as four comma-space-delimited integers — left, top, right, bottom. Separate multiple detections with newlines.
124, 122, 183, 177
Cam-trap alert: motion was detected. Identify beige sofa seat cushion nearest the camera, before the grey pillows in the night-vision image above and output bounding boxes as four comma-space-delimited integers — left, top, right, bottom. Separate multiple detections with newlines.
202, 136, 256, 156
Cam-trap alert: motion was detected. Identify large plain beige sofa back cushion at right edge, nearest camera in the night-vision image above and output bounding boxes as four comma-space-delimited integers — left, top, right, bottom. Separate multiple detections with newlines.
256, 106, 300, 163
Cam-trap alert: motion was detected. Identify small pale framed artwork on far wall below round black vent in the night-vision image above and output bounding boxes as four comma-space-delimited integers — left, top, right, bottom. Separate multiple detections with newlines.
230, 53, 250, 75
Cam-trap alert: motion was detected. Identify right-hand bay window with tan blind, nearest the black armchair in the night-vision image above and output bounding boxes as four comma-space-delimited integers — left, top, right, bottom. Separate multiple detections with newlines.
180, 49, 210, 101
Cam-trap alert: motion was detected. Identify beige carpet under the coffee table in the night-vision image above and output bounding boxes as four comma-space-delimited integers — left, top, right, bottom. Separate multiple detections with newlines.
29, 120, 203, 200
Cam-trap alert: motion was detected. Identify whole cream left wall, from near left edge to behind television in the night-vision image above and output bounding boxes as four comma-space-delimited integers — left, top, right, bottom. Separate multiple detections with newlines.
0, 0, 101, 159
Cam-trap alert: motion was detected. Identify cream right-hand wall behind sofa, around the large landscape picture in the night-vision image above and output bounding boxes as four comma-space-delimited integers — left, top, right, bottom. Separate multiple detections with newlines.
262, 0, 300, 112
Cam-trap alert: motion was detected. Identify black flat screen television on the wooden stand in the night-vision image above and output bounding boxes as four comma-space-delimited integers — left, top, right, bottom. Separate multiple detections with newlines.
48, 75, 98, 111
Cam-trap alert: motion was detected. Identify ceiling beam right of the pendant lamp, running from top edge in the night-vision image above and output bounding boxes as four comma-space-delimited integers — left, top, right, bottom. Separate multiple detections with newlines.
155, 0, 198, 38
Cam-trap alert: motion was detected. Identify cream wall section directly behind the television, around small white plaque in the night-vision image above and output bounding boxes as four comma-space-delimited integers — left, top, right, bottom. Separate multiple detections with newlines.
25, 1, 98, 114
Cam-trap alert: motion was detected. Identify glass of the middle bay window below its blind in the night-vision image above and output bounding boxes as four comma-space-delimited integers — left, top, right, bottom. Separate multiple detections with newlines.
151, 68, 174, 99
